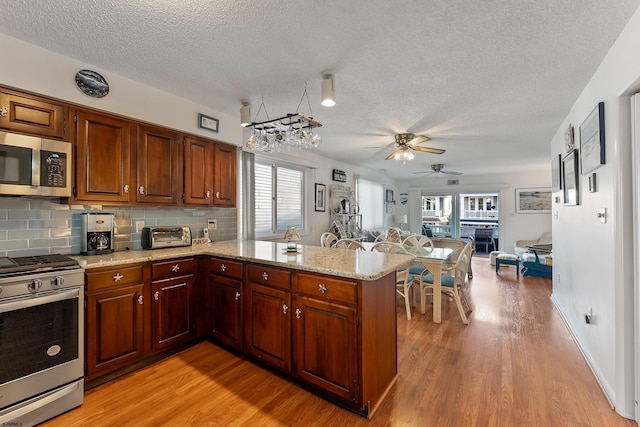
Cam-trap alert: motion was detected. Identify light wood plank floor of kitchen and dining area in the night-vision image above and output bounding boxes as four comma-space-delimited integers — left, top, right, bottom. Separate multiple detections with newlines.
45, 257, 637, 427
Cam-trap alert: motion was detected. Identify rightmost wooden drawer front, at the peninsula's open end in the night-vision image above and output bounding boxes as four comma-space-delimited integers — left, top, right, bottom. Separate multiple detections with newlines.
293, 273, 358, 304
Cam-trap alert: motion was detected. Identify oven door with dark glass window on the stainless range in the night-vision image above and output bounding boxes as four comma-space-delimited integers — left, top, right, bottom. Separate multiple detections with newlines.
0, 287, 84, 410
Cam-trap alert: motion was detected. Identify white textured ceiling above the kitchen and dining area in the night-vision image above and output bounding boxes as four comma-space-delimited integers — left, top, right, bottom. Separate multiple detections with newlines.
0, 0, 640, 178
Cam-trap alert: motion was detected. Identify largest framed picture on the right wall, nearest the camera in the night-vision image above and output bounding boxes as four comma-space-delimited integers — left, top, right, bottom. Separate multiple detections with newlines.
580, 102, 605, 175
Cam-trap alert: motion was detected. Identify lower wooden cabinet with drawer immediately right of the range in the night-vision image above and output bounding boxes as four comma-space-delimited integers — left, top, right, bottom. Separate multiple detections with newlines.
85, 265, 145, 379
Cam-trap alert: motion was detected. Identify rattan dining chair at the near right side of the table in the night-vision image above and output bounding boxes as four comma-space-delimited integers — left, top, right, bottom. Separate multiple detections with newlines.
420, 242, 473, 325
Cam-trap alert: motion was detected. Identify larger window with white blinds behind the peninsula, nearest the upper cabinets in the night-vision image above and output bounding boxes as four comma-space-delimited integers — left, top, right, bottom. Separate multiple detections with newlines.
254, 157, 304, 236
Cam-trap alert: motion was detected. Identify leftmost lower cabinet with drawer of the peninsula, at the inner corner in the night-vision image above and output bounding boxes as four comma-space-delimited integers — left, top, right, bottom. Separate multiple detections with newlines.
209, 258, 244, 350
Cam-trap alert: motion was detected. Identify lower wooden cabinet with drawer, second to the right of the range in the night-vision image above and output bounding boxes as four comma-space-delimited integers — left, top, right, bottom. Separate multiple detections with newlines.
151, 258, 197, 351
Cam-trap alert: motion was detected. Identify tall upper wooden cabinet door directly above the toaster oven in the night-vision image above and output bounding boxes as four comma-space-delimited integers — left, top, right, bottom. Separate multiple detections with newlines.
136, 125, 180, 204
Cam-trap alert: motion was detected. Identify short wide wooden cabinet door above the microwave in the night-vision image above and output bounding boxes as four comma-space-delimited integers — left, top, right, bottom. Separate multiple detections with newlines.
0, 92, 69, 139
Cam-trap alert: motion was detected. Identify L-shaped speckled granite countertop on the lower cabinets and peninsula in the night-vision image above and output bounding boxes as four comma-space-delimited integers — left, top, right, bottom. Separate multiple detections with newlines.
72, 240, 413, 280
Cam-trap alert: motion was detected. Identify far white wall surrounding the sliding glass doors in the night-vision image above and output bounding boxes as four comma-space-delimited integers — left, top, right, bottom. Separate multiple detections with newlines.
397, 168, 557, 252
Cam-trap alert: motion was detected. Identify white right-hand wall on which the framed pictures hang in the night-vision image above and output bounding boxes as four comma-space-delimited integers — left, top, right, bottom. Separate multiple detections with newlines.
551, 3, 640, 418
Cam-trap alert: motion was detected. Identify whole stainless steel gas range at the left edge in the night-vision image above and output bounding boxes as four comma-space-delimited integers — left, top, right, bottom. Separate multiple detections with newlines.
0, 255, 84, 426
